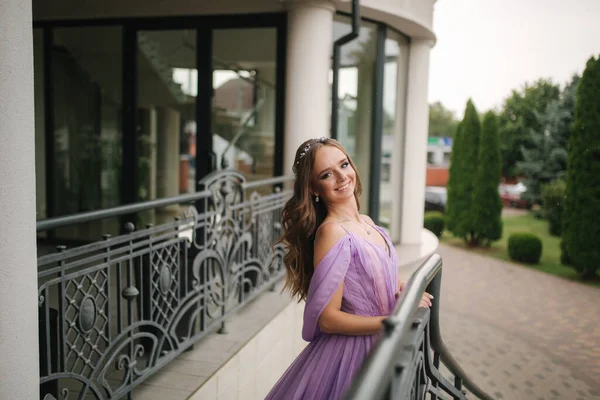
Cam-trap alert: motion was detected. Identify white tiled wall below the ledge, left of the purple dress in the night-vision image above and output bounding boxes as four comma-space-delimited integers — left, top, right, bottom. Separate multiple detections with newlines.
189, 301, 306, 400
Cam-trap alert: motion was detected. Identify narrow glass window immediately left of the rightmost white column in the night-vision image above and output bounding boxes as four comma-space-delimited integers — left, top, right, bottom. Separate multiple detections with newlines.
379, 29, 408, 241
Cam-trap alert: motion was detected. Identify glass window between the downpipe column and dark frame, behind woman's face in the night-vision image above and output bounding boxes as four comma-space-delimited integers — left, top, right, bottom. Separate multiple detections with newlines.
333, 15, 377, 212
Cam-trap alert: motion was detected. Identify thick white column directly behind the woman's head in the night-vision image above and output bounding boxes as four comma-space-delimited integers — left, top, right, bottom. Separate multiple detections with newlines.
283, 0, 335, 174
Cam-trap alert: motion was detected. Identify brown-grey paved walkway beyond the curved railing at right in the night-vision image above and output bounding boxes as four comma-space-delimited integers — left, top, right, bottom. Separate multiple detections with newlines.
404, 245, 600, 400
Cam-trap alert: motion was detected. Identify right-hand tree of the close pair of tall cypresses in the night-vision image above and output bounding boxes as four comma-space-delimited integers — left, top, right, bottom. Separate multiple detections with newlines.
471, 111, 502, 245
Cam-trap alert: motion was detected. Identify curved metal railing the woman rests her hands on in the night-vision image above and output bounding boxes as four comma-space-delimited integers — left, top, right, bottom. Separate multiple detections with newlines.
345, 254, 492, 400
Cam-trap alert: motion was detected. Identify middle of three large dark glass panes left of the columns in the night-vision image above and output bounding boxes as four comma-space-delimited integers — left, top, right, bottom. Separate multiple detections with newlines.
136, 30, 198, 224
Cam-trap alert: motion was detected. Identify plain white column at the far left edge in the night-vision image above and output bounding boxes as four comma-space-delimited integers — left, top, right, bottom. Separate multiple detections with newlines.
0, 0, 40, 399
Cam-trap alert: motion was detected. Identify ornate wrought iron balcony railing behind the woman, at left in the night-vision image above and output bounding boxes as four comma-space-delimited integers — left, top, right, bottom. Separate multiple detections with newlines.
38, 171, 291, 400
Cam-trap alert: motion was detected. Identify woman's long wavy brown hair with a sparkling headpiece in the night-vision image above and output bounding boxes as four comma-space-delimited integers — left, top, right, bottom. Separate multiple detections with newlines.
278, 138, 362, 300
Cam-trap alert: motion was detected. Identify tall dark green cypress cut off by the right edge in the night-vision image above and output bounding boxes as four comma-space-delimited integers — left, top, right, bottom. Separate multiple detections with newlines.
561, 57, 600, 278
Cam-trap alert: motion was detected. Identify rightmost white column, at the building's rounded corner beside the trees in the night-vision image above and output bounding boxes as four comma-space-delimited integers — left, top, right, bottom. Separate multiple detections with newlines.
401, 39, 433, 244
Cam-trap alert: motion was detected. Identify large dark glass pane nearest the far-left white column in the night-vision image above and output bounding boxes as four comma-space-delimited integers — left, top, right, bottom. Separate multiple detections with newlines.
51, 27, 123, 240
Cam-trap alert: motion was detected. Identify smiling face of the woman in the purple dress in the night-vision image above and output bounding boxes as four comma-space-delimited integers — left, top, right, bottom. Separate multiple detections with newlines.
312, 146, 356, 205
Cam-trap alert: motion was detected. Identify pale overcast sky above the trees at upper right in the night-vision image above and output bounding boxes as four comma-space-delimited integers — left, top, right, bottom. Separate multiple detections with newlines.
429, 0, 600, 117
